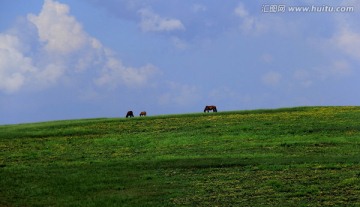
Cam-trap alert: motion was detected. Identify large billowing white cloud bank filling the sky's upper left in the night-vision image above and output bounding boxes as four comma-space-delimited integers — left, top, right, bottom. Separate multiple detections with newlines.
0, 0, 160, 93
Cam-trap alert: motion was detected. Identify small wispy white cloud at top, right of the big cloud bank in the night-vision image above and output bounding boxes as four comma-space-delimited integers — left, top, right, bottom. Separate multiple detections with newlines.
138, 8, 185, 32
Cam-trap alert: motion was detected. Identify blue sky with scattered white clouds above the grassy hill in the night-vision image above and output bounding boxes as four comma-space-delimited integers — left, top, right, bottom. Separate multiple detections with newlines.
0, 0, 360, 125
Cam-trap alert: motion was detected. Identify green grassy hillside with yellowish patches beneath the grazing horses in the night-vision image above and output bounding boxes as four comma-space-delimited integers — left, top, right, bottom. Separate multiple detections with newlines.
0, 107, 360, 206
